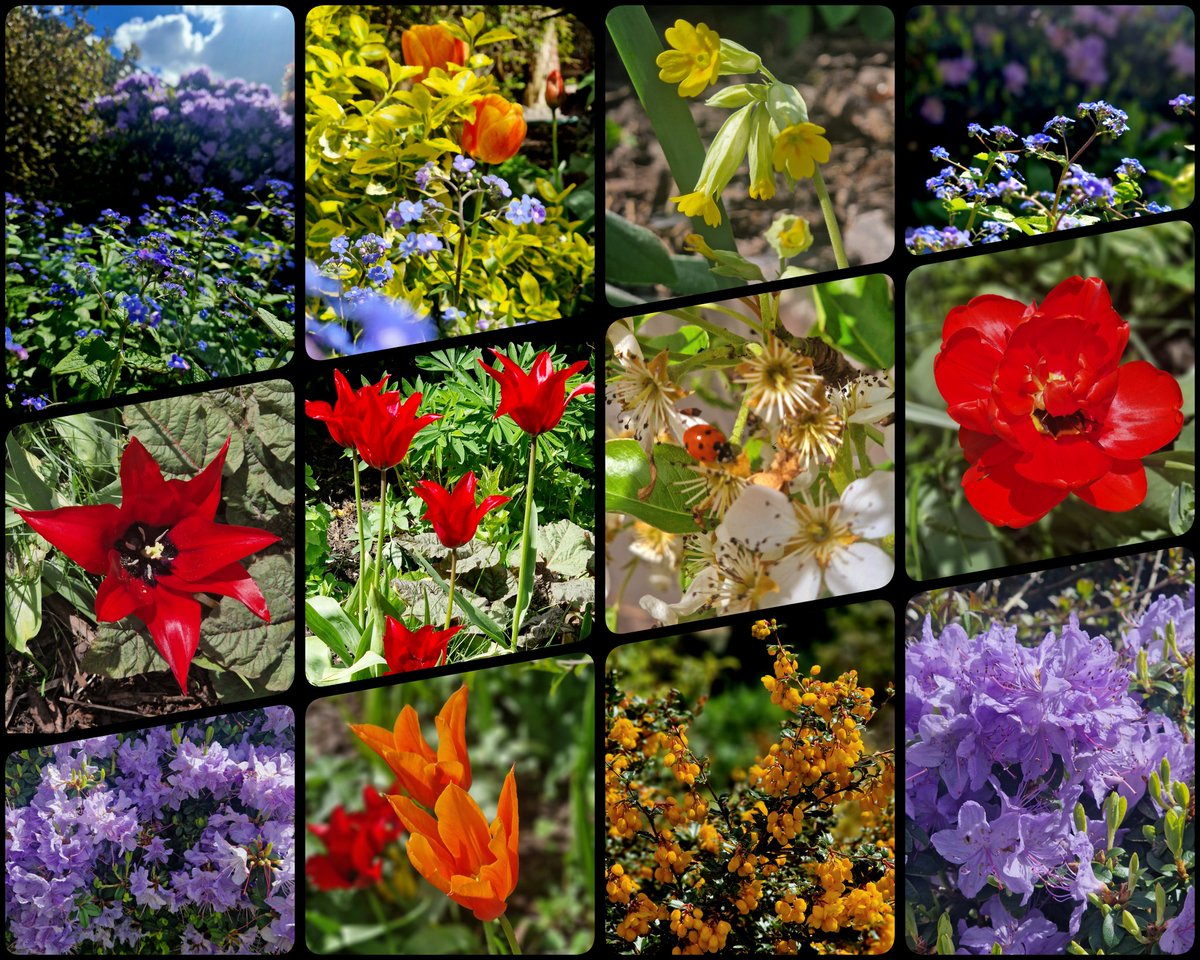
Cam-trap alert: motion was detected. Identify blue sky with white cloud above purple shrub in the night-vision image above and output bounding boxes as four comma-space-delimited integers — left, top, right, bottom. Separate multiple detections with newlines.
88, 4, 295, 92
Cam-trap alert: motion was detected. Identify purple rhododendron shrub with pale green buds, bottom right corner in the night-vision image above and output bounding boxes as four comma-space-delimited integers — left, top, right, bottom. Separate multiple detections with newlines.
905, 581, 1195, 954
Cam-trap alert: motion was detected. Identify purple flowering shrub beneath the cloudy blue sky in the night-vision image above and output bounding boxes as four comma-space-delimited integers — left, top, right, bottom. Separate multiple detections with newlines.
89, 67, 295, 206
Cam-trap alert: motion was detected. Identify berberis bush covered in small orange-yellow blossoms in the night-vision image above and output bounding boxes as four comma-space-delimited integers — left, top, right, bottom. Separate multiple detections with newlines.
605, 620, 895, 955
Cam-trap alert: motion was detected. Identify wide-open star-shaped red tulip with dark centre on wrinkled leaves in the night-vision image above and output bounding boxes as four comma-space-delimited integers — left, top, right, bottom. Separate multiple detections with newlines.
17, 437, 280, 694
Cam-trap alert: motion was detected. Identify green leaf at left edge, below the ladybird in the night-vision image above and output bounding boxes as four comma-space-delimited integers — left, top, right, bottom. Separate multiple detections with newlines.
605, 439, 696, 533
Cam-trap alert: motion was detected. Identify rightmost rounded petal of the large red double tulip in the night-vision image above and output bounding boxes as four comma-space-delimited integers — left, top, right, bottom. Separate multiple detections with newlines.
1097, 360, 1183, 460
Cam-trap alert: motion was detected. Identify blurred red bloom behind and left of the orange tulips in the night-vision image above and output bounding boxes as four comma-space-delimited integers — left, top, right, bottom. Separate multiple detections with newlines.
305, 786, 404, 890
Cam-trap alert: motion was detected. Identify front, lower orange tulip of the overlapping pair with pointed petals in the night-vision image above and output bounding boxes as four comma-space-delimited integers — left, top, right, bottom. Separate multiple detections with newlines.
388, 769, 518, 923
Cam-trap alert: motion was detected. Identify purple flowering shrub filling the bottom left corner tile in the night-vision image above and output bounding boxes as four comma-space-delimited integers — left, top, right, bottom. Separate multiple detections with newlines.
5, 707, 295, 954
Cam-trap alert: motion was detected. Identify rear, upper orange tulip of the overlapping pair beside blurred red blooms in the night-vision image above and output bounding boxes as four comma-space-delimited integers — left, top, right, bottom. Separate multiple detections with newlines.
350, 684, 470, 810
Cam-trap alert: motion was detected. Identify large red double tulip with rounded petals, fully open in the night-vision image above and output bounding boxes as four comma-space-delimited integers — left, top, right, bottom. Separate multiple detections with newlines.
934, 277, 1183, 527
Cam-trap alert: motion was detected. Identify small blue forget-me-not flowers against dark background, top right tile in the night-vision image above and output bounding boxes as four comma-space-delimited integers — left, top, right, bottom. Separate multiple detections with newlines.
905, 94, 1195, 253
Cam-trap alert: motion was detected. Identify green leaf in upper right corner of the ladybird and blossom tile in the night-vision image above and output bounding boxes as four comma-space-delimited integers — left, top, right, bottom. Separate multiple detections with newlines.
812, 274, 895, 370
